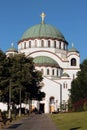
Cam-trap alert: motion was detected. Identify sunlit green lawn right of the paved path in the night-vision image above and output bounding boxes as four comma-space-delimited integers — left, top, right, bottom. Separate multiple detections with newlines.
51, 111, 87, 130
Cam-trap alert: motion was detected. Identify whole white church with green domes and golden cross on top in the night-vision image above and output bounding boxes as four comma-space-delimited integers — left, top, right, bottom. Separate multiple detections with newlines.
6, 13, 80, 113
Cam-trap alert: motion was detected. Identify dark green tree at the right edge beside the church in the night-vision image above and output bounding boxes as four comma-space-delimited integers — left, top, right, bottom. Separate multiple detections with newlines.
70, 60, 87, 109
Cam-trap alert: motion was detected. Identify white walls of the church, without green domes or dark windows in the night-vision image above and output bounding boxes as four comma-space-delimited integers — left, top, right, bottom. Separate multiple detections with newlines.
16, 39, 80, 113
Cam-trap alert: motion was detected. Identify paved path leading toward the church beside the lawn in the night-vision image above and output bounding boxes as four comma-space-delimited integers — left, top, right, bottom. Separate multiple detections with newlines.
2, 114, 58, 130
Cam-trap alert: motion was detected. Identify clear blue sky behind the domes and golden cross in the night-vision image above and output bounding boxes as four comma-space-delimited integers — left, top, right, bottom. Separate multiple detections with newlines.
0, 0, 87, 62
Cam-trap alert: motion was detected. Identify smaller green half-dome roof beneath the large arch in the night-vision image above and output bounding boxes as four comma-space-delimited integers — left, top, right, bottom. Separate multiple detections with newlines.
34, 56, 59, 67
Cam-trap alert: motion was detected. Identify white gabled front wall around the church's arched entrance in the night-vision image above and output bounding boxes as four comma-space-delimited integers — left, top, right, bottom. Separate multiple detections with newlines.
41, 77, 60, 113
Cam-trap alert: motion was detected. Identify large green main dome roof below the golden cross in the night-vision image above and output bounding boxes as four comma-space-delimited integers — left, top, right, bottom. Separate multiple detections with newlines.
21, 23, 65, 41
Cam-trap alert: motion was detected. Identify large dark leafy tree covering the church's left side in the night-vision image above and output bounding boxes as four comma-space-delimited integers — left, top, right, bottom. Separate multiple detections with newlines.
0, 50, 43, 104
